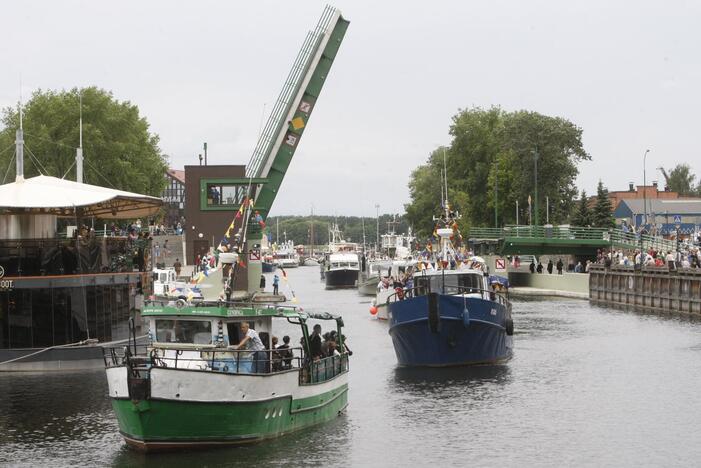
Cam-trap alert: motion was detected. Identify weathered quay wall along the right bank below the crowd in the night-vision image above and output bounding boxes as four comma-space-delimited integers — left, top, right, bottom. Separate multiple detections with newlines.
589, 265, 701, 316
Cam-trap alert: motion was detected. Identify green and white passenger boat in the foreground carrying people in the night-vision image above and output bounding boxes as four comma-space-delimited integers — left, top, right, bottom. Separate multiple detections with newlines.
105, 302, 348, 451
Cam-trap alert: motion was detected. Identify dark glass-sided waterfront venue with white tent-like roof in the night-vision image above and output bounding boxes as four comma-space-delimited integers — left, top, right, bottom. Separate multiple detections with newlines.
0, 172, 162, 371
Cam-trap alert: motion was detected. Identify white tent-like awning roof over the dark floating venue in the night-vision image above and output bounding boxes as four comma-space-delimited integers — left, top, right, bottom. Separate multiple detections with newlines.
0, 176, 163, 219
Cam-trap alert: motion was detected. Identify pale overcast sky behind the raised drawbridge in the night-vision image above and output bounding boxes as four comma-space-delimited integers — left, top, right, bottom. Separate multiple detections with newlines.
0, 0, 701, 216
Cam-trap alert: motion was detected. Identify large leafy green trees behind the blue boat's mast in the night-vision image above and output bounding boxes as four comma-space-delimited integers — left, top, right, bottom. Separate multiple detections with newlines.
405, 107, 590, 230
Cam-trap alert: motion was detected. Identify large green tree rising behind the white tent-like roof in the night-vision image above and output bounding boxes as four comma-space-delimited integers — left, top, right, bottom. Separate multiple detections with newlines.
0, 87, 167, 196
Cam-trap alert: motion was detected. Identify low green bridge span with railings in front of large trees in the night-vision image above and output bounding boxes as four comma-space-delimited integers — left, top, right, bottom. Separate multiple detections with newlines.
465, 226, 676, 256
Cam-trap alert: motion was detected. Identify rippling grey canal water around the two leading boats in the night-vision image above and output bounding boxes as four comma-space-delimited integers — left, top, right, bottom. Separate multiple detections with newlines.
0, 267, 701, 467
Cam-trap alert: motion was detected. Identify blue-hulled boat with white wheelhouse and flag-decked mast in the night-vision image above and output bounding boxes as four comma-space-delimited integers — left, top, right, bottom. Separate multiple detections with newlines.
387, 202, 514, 367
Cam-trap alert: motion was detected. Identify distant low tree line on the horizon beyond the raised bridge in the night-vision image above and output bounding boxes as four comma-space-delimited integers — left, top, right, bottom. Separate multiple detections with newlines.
265, 214, 409, 245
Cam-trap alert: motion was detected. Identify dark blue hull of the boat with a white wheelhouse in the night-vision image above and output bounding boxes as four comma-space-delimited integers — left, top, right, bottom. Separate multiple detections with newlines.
389, 294, 513, 367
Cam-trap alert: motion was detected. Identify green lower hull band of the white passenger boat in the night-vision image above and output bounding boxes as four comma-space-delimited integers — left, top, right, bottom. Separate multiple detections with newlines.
112, 384, 348, 449
